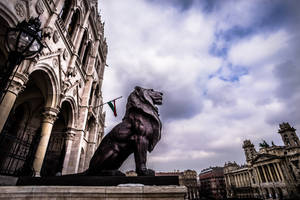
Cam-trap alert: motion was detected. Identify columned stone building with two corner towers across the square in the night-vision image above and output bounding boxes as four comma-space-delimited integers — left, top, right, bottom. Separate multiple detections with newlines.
224, 123, 300, 199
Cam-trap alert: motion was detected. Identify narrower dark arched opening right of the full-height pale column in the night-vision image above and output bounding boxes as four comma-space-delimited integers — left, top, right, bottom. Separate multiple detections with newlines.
41, 101, 72, 176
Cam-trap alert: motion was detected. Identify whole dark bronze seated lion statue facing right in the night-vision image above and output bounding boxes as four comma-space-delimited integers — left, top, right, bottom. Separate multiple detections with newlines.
85, 86, 163, 176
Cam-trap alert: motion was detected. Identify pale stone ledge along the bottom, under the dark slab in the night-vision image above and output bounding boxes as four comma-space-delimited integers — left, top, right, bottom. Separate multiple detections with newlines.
0, 186, 186, 200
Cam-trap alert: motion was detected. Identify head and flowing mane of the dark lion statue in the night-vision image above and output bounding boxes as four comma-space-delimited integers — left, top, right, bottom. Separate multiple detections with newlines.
124, 86, 163, 152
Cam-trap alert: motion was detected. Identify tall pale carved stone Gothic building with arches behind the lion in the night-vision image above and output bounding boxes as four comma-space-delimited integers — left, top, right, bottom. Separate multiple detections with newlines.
0, 0, 107, 176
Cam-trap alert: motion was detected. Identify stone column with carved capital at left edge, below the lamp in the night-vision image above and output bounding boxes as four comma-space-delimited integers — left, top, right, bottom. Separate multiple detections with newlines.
0, 74, 28, 133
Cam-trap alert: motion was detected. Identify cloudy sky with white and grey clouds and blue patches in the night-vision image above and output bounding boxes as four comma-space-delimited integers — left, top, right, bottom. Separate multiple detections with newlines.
99, 0, 300, 172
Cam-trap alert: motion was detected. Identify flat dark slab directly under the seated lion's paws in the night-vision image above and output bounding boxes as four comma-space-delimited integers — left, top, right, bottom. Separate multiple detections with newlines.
17, 176, 179, 186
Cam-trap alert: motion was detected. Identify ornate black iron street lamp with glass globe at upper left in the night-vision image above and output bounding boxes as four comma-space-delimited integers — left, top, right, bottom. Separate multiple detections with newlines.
0, 17, 44, 104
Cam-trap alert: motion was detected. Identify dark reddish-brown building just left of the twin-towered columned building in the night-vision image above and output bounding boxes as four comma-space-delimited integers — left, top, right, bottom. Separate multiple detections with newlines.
199, 167, 226, 199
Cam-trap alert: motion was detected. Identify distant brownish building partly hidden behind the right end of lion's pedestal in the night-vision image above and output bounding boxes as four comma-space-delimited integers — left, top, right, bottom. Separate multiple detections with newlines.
155, 169, 200, 200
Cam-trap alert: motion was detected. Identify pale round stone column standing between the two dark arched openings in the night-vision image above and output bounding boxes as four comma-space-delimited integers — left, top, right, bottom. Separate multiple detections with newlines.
33, 108, 58, 176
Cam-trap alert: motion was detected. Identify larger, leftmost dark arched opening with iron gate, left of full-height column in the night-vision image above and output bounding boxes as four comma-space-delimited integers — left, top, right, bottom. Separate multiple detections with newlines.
0, 70, 52, 175
